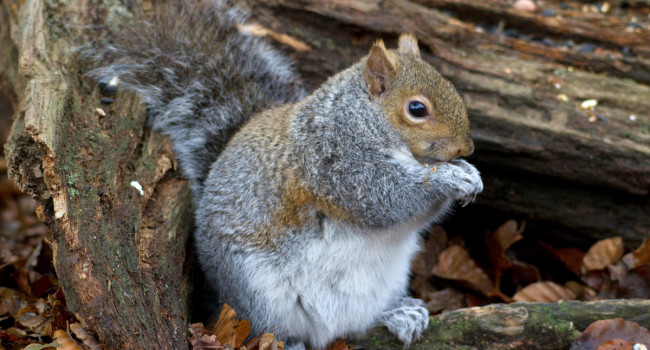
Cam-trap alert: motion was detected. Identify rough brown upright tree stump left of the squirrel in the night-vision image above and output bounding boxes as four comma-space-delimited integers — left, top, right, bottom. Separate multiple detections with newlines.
0, 0, 192, 349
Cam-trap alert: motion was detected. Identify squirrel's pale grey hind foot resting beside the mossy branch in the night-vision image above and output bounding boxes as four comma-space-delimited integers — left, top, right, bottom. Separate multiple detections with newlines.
379, 298, 429, 348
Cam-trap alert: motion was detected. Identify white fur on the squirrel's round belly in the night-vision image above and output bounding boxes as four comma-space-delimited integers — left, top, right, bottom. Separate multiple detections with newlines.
251, 216, 426, 347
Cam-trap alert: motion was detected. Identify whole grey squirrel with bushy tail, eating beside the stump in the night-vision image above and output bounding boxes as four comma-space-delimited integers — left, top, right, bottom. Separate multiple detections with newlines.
90, 1, 483, 349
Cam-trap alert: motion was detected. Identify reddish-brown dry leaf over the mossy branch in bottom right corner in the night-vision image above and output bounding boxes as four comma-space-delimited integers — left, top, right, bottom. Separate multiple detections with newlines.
571, 318, 650, 350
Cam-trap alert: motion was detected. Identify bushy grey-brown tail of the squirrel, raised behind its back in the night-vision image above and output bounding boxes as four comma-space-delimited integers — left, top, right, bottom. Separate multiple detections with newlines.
89, 0, 304, 201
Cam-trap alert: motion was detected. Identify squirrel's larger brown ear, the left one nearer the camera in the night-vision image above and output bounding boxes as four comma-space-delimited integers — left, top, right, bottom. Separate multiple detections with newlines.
365, 40, 395, 96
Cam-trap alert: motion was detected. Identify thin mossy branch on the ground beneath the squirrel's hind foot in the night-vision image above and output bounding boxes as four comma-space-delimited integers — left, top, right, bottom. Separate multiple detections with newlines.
348, 299, 650, 350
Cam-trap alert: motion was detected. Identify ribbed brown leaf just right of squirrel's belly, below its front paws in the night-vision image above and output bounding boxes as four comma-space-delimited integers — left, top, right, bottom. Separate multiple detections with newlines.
432, 245, 493, 295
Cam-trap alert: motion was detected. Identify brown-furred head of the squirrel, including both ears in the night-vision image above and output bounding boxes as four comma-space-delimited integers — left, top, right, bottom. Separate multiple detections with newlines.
364, 34, 474, 162
